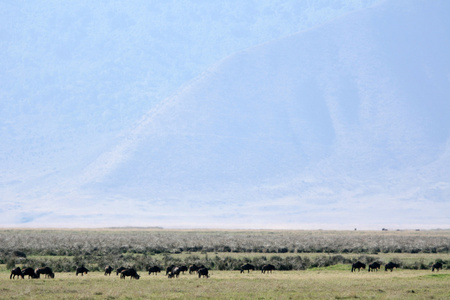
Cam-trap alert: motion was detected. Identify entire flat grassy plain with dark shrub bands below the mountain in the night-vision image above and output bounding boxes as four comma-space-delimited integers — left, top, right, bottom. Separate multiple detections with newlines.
0, 229, 450, 299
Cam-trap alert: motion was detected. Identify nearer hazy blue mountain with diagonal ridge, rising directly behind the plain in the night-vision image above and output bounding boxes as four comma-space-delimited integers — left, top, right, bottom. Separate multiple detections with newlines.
3, 1, 450, 228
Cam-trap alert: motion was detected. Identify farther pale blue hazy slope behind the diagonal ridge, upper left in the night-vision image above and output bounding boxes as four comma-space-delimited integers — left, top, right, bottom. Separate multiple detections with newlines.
0, 0, 374, 182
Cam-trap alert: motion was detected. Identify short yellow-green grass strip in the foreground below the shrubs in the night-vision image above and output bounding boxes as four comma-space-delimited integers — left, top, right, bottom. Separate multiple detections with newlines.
0, 265, 450, 299
